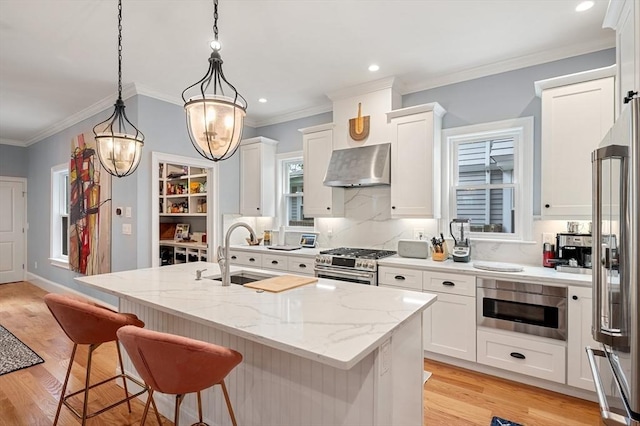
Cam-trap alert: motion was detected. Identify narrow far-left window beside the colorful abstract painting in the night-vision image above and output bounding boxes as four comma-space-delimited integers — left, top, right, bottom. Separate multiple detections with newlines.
50, 164, 69, 268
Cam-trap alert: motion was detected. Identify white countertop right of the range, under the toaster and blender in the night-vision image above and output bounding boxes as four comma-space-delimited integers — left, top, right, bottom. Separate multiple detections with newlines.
378, 256, 591, 287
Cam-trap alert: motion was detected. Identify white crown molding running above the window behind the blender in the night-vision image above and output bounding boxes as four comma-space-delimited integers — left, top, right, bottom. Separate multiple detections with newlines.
400, 35, 615, 95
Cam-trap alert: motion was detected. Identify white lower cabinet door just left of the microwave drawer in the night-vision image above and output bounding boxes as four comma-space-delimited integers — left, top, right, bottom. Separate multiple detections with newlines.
422, 293, 476, 362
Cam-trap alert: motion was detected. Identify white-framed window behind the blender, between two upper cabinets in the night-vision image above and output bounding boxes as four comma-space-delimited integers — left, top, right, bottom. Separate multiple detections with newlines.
443, 117, 533, 240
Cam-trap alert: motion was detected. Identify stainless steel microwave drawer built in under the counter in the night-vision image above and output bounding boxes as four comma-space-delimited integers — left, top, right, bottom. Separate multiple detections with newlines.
476, 278, 567, 340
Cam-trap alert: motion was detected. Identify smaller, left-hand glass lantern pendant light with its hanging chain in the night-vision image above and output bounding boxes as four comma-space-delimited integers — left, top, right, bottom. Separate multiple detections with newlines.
93, 0, 144, 177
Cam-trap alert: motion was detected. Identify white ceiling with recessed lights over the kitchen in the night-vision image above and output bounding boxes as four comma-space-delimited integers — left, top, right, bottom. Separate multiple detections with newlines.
0, 0, 615, 145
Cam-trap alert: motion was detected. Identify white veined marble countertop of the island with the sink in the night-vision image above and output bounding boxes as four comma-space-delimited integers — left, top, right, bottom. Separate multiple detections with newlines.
76, 262, 436, 370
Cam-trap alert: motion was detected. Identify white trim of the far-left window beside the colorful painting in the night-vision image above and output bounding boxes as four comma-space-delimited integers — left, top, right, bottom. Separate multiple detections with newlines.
49, 163, 69, 269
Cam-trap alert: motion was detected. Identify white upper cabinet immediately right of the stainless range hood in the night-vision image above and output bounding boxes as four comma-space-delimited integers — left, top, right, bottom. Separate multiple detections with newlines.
387, 102, 446, 218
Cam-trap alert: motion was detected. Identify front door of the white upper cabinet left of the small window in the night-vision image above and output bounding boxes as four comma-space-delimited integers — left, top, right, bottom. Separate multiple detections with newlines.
240, 144, 262, 216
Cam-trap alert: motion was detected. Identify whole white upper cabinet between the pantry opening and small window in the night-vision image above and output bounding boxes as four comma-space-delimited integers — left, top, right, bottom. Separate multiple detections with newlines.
240, 136, 278, 216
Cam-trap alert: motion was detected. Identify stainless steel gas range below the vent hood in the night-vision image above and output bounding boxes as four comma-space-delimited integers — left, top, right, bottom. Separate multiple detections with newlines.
314, 247, 396, 285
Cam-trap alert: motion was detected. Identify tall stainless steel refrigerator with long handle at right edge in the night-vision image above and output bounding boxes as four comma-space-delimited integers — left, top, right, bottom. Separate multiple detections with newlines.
586, 93, 640, 426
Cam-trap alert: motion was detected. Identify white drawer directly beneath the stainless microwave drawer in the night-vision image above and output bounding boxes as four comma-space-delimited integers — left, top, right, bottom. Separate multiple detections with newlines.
477, 329, 566, 383
